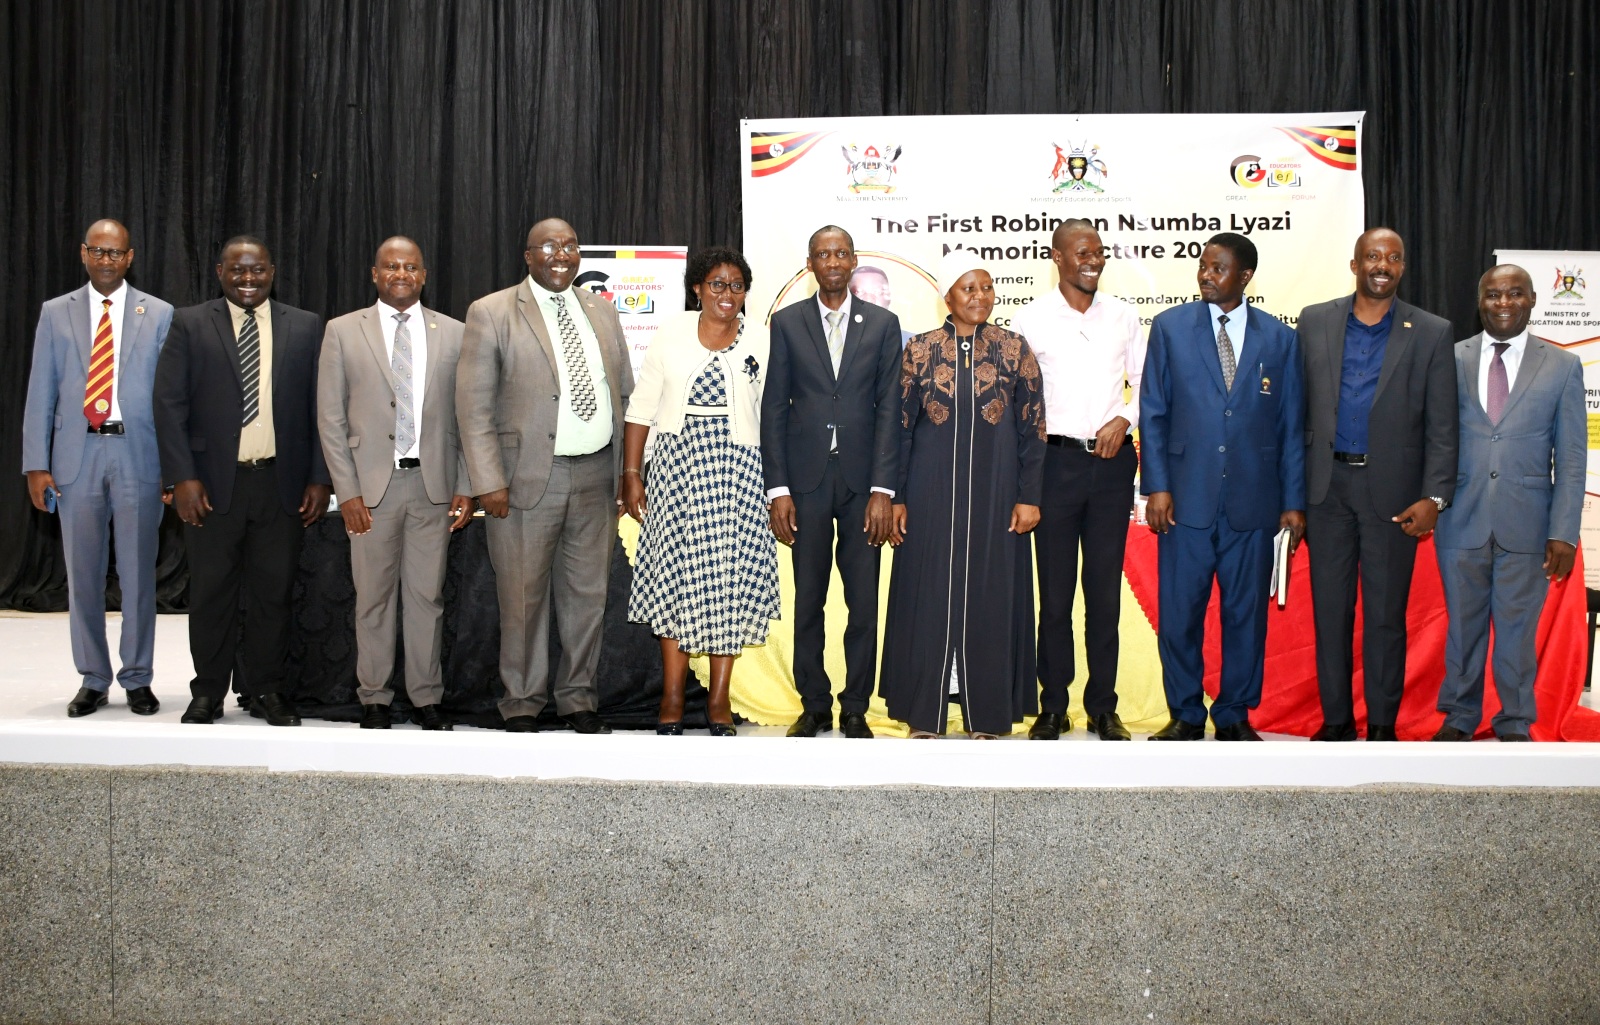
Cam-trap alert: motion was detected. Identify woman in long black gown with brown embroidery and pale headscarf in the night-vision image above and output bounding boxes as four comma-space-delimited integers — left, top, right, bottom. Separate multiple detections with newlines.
878, 249, 1045, 739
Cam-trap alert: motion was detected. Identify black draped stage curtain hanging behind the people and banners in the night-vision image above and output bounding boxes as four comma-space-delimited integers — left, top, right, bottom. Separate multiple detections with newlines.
0, 0, 1600, 609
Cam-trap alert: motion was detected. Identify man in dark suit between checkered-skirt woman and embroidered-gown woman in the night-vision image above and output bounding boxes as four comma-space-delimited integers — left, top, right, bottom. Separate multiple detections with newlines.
762, 224, 901, 739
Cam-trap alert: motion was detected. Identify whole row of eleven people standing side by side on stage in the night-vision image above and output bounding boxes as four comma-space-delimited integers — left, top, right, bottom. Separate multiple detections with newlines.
22, 219, 1586, 740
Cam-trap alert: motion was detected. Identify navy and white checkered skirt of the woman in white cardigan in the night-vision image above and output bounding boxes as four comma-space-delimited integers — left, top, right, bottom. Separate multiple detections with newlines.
627, 416, 779, 656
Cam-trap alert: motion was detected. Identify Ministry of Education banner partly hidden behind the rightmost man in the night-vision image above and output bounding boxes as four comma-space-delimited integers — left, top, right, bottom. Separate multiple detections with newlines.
1494, 249, 1600, 588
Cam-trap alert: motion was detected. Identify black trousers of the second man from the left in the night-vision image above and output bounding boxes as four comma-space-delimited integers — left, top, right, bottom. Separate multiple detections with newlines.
184, 465, 306, 699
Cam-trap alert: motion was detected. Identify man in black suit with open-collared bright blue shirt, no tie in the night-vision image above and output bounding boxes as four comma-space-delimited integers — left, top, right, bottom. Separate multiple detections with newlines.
1299, 227, 1459, 740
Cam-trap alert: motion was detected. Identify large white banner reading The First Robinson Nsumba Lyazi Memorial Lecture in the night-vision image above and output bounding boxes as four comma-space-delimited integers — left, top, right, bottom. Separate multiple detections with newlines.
742, 110, 1363, 333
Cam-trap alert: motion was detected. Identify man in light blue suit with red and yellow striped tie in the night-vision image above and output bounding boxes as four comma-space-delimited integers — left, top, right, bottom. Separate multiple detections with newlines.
22, 221, 173, 716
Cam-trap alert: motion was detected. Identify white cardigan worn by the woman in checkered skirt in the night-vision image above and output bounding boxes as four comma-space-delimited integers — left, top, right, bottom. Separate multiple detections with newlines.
626, 312, 771, 446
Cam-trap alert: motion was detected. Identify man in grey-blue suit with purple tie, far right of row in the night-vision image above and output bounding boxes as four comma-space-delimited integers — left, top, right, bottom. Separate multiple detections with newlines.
1434, 264, 1587, 740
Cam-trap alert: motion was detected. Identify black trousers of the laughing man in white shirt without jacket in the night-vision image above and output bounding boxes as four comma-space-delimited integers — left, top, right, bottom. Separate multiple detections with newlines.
1034, 443, 1139, 718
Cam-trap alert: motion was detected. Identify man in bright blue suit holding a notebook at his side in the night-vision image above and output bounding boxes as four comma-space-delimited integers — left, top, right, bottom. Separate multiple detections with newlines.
1139, 232, 1306, 740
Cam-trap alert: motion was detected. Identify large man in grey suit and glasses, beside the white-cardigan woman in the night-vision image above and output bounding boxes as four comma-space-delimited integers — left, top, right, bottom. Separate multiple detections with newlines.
456, 217, 634, 734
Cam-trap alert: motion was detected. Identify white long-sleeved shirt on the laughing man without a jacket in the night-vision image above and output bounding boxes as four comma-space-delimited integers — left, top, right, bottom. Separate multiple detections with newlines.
1011, 288, 1147, 440
